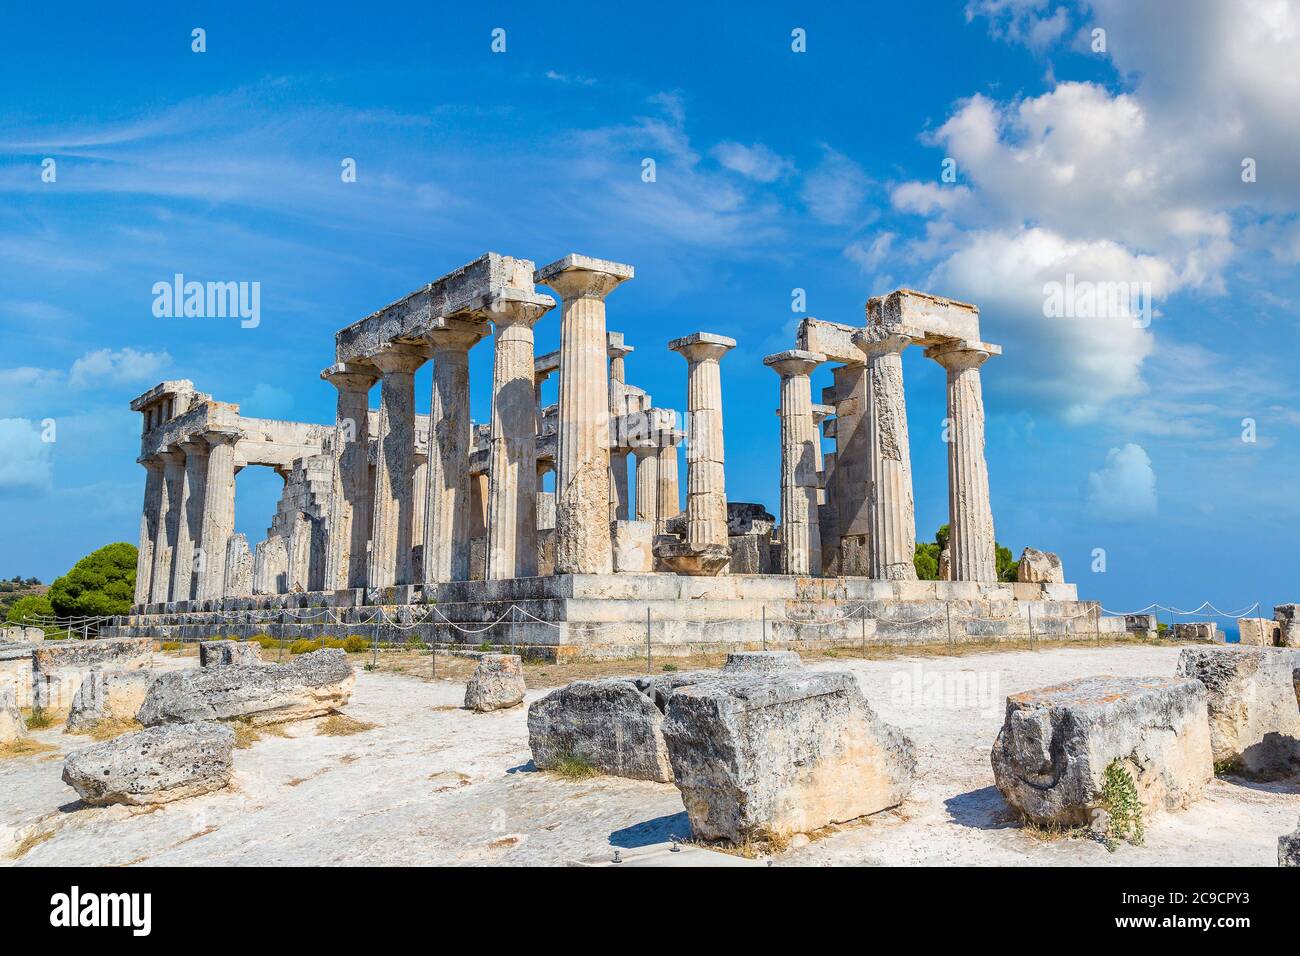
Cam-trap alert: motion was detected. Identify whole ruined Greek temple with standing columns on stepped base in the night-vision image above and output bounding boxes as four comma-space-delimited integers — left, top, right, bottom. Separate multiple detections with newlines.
118, 252, 1122, 653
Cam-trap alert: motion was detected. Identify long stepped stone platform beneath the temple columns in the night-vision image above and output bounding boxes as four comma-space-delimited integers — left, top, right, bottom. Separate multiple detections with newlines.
104, 574, 1126, 659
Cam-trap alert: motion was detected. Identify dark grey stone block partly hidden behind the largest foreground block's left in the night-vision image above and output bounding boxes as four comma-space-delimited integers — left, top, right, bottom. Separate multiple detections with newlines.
528, 672, 701, 783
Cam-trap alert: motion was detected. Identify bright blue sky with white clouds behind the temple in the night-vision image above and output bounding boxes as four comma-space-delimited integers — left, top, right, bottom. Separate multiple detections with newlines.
0, 0, 1300, 621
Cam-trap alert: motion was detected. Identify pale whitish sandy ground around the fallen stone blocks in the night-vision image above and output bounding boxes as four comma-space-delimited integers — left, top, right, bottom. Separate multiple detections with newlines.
0, 646, 1300, 866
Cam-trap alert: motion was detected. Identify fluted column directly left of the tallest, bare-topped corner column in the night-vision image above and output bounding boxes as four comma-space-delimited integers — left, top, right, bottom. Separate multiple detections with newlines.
486, 298, 554, 580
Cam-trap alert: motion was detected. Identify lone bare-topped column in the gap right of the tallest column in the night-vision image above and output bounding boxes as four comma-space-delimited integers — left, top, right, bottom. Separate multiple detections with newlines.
668, 332, 736, 549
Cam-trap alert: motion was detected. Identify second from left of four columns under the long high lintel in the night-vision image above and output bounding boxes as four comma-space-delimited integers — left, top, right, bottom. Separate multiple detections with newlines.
365, 345, 425, 588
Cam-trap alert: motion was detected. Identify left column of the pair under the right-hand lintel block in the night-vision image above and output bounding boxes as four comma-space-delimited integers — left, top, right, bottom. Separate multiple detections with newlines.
853, 328, 917, 581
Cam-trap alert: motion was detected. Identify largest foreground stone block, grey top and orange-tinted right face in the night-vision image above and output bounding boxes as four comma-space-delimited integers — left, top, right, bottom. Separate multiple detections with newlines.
663, 671, 917, 843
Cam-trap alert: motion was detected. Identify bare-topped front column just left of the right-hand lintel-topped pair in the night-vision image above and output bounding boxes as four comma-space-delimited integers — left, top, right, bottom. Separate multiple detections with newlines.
763, 349, 826, 575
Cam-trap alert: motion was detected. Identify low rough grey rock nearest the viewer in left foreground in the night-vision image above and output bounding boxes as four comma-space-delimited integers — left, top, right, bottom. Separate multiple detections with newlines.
64, 723, 235, 806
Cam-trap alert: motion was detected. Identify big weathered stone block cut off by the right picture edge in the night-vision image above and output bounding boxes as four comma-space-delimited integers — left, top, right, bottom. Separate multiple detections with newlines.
1177, 646, 1300, 774
